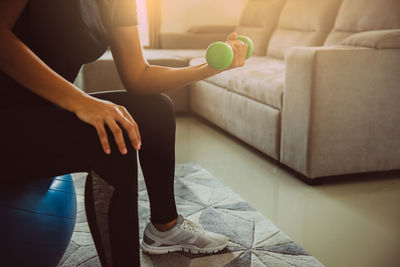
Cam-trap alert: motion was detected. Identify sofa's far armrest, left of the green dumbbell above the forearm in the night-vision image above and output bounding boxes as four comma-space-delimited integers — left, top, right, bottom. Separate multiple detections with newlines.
160, 32, 228, 49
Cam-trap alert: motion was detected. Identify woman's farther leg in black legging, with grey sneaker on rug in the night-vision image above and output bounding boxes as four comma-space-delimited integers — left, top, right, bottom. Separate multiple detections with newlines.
88, 92, 228, 258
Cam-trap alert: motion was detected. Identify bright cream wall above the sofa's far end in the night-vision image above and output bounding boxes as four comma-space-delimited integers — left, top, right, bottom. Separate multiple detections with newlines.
161, 0, 248, 32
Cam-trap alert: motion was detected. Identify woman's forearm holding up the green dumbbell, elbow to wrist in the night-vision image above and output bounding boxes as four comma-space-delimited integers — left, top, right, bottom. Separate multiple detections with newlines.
127, 63, 220, 94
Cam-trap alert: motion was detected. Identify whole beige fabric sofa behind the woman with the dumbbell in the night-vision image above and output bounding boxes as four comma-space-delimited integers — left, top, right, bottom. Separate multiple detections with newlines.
76, 0, 400, 182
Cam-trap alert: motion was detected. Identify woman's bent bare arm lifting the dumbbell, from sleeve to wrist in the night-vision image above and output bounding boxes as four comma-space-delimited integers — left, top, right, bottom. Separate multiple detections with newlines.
110, 26, 225, 94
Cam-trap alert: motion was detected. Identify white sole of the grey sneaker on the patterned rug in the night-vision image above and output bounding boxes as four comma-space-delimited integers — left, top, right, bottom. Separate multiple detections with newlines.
140, 241, 228, 255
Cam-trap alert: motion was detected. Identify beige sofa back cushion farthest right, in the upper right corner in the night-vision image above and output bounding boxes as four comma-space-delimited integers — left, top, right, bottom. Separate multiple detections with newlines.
325, 0, 400, 45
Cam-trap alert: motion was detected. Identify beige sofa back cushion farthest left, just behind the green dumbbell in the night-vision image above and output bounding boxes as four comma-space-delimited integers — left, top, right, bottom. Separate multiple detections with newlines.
235, 0, 285, 56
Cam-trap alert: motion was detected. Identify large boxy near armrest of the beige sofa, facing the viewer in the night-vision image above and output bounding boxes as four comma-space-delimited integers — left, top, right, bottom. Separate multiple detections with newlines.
280, 47, 400, 178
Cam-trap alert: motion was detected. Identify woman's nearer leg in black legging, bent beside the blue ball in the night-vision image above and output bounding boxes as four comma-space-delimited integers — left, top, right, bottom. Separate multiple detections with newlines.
0, 103, 139, 266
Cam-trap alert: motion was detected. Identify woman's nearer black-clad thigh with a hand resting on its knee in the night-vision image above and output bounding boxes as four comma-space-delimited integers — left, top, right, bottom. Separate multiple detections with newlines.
0, 104, 136, 185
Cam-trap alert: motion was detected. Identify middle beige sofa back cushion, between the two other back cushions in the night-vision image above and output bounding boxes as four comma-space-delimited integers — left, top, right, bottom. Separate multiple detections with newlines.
267, 0, 342, 59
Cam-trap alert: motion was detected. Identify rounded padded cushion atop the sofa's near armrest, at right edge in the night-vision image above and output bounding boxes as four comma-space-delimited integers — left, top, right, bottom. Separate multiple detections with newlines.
342, 30, 400, 49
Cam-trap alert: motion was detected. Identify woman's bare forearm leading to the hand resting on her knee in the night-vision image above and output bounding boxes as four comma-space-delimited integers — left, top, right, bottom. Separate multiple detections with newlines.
0, 29, 87, 111
